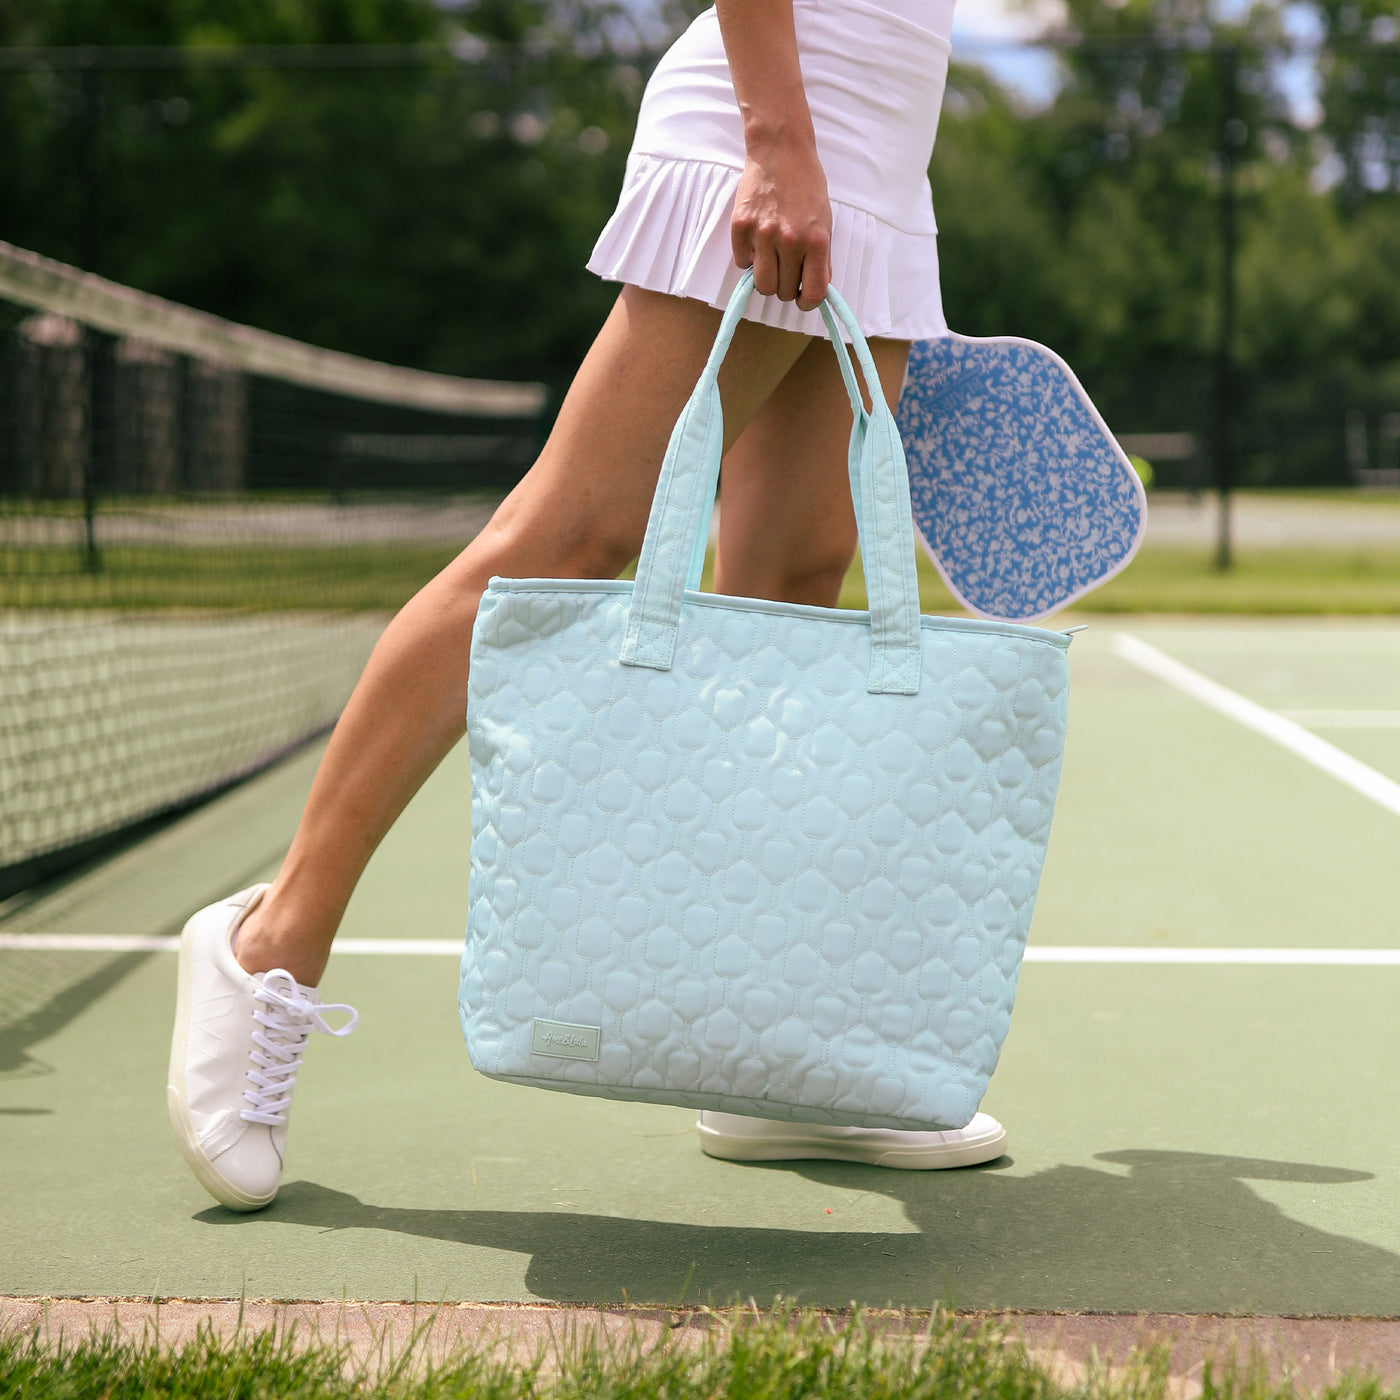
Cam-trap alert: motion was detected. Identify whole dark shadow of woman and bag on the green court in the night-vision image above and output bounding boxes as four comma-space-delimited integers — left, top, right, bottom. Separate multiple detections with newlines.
196, 1151, 1400, 1316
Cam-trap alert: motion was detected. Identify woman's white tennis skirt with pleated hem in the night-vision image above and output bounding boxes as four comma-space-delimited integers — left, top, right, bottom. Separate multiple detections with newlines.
588, 0, 953, 340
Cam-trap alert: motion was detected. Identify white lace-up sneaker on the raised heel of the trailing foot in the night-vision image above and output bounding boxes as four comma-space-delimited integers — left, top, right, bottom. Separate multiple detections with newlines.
165, 885, 360, 1211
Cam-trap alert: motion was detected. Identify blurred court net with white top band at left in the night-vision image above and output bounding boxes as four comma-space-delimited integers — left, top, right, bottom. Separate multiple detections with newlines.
0, 244, 546, 899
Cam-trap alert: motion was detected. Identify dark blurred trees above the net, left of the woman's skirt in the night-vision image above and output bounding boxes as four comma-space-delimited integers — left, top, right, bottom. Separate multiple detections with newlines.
0, 0, 641, 375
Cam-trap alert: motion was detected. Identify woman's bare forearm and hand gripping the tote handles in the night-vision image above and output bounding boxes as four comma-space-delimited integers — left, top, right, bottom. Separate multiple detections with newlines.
715, 0, 832, 311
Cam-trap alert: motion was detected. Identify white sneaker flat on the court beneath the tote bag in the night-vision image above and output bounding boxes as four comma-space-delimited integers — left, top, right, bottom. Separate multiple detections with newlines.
696, 1109, 1007, 1170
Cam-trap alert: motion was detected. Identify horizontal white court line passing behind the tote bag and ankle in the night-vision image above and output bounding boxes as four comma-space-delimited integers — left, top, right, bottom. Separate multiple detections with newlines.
0, 934, 1400, 967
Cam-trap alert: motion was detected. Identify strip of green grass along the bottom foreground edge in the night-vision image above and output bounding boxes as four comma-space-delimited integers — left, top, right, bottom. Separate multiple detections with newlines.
0, 1309, 1397, 1400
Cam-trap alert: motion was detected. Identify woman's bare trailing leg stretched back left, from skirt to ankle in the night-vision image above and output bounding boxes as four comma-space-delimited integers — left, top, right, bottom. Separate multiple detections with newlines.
237, 287, 817, 986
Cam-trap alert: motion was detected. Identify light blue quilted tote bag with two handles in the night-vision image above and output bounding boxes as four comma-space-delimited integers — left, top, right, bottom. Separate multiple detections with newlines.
459, 267, 1070, 1128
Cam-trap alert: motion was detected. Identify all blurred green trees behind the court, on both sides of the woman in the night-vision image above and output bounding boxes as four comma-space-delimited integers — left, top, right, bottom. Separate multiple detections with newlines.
0, 0, 1400, 484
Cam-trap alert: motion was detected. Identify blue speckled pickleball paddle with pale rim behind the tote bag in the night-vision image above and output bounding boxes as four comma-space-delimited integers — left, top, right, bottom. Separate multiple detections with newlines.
896, 335, 1147, 622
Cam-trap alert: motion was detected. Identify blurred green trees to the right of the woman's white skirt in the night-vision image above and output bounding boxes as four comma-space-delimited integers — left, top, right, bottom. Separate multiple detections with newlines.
931, 0, 1400, 368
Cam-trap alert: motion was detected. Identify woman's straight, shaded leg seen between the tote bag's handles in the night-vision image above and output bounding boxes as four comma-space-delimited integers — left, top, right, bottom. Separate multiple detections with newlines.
714, 340, 909, 608
